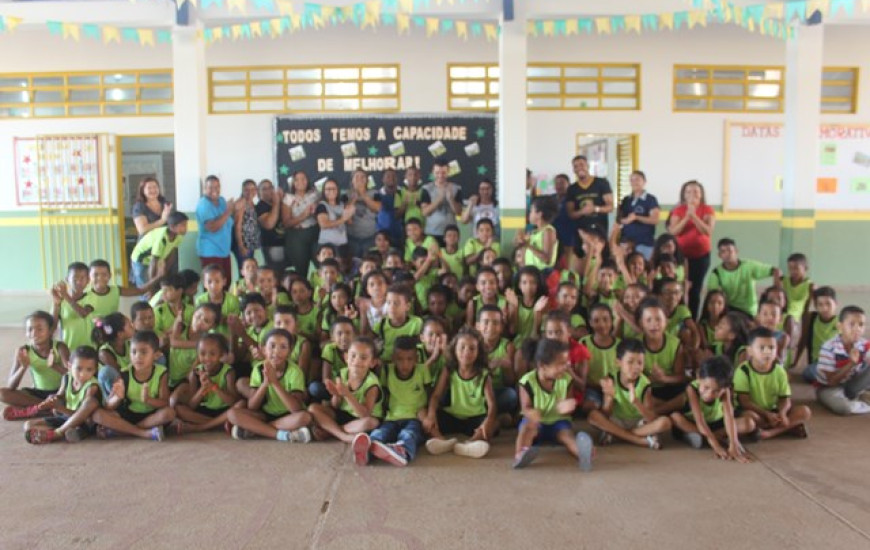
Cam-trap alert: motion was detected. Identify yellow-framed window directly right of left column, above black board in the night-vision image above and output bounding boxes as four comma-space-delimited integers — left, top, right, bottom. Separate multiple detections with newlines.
208, 65, 400, 114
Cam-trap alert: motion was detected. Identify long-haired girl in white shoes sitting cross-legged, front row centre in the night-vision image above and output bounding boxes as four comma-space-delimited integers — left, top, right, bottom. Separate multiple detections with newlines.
423, 327, 498, 458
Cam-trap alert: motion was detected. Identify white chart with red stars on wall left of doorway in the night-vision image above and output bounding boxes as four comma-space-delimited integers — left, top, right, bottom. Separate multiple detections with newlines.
14, 136, 101, 206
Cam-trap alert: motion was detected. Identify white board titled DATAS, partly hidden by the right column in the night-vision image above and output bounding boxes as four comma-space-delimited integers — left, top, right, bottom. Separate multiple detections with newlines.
722, 122, 870, 210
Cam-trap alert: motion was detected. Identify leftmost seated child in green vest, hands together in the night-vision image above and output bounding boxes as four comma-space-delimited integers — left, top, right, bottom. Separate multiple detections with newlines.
0, 311, 69, 420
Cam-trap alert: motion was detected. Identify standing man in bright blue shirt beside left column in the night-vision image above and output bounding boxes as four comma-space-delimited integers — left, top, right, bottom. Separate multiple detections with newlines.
196, 176, 235, 284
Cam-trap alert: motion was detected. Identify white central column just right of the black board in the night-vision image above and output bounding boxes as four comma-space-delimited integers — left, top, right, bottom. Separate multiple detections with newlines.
497, 0, 528, 222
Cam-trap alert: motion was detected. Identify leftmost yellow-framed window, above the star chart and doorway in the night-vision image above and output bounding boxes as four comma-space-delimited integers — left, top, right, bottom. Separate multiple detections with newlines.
0, 69, 173, 118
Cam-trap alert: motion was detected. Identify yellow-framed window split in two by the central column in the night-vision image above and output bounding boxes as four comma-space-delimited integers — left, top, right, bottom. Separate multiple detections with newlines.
447, 63, 640, 110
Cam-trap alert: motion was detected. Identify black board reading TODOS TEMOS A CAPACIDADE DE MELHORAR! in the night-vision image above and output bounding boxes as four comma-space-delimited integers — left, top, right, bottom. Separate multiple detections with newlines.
274, 114, 497, 196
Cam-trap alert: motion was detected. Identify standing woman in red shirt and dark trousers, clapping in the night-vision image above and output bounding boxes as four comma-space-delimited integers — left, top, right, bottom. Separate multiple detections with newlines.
668, 180, 716, 319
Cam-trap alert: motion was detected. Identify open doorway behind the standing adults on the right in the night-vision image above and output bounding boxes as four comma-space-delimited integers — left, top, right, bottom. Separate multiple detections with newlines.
577, 133, 638, 208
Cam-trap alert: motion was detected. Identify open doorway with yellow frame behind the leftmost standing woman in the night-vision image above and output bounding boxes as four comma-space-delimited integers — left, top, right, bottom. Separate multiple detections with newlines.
116, 134, 176, 280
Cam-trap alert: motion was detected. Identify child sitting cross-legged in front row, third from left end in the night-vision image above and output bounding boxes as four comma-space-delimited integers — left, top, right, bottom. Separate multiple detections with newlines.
93, 332, 175, 441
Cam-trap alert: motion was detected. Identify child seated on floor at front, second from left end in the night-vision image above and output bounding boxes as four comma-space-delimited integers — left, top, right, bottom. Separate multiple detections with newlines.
24, 346, 100, 444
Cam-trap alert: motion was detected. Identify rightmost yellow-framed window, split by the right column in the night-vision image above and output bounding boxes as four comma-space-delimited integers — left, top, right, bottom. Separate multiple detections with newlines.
674, 65, 858, 113
